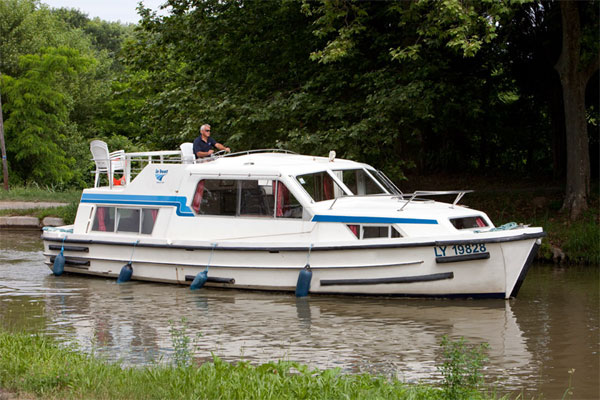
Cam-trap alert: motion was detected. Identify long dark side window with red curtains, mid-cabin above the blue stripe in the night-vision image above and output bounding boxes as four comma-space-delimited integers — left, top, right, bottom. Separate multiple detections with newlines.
192, 179, 302, 218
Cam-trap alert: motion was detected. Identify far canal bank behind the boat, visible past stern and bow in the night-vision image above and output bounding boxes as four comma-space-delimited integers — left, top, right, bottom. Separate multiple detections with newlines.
0, 180, 600, 265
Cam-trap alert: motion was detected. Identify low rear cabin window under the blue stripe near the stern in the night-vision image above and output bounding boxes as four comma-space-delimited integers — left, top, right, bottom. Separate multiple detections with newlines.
92, 207, 158, 235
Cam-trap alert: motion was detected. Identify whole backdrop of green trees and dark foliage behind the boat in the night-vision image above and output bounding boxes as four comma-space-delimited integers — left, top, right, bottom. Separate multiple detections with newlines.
0, 0, 599, 188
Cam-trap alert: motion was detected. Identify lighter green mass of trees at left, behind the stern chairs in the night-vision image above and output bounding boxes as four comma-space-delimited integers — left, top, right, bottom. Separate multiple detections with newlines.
0, 0, 132, 186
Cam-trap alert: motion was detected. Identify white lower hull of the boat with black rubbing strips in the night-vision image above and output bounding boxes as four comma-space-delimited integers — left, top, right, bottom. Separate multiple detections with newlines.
43, 228, 544, 298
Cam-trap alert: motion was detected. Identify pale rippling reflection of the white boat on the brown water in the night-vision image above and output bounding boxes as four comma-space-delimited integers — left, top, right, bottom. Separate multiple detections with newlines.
39, 277, 531, 380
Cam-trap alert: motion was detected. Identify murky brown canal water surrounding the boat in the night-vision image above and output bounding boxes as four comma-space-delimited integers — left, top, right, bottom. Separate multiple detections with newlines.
0, 231, 600, 399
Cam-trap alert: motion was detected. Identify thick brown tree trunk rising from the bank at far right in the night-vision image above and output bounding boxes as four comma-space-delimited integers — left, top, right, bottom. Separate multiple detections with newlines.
555, 1, 598, 220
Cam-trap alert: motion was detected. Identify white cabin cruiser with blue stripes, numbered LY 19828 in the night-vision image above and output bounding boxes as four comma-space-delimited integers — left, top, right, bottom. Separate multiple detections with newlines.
42, 145, 545, 298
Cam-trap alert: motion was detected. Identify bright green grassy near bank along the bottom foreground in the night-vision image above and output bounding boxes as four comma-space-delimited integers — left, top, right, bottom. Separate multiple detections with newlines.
0, 332, 504, 399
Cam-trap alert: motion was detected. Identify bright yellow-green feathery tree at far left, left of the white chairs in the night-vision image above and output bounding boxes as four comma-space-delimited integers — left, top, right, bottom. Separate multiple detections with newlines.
2, 47, 93, 185
